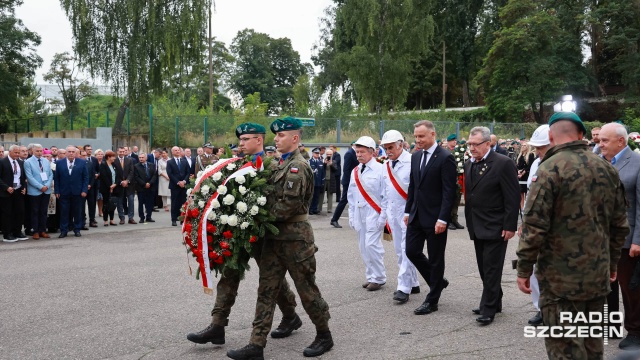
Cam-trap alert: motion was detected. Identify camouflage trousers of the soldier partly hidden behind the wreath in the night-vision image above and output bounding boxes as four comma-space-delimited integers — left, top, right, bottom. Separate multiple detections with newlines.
211, 248, 296, 326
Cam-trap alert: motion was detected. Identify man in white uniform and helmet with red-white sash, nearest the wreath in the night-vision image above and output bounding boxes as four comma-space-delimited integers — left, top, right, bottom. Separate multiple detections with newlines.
347, 136, 387, 291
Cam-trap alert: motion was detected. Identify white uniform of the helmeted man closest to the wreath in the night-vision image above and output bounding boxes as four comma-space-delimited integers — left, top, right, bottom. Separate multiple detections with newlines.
347, 157, 387, 284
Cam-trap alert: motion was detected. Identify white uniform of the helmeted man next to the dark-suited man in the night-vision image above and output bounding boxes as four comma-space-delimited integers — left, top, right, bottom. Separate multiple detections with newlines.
383, 151, 420, 294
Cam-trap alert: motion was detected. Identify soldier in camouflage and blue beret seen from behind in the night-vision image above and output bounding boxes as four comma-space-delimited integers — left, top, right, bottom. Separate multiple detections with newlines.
517, 112, 629, 359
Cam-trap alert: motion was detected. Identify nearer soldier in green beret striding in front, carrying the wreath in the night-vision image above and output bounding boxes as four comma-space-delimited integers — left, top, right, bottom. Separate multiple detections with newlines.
227, 118, 333, 360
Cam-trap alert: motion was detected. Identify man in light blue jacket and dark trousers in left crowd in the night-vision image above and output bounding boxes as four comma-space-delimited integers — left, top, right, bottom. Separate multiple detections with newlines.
24, 144, 53, 240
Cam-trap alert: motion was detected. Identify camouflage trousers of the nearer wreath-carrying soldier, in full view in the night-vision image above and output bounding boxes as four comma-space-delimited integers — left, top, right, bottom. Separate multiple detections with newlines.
250, 240, 330, 347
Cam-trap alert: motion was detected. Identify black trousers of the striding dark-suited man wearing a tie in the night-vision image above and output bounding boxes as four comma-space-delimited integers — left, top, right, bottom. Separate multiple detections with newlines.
405, 225, 447, 305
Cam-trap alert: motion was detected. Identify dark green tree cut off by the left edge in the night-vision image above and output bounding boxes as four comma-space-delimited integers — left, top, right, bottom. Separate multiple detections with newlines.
0, 0, 42, 125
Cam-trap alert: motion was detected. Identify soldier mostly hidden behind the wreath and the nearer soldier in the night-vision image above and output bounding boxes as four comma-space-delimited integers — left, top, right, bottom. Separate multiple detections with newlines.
187, 123, 302, 344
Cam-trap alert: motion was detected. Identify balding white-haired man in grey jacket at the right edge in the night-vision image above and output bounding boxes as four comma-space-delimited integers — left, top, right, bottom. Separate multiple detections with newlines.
599, 123, 640, 350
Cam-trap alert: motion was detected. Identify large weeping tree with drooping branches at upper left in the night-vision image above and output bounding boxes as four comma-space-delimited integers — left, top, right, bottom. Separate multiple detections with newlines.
60, 0, 212, 131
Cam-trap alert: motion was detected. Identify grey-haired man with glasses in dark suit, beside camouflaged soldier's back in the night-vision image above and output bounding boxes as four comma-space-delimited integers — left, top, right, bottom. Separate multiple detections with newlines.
464, 126, 520, 325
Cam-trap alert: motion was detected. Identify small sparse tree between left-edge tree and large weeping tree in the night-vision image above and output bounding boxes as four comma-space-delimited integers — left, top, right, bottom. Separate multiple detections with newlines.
42, 51, 96, 114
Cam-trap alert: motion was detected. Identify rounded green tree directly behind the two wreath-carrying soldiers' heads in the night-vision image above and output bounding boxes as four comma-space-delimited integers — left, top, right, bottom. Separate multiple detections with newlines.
230, 29, 306, 114
